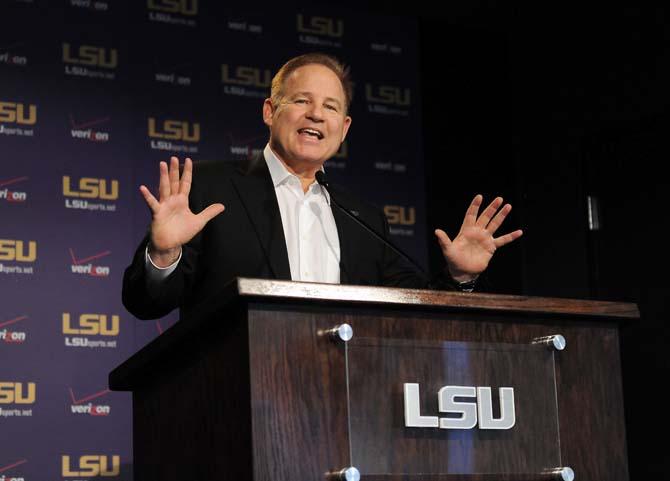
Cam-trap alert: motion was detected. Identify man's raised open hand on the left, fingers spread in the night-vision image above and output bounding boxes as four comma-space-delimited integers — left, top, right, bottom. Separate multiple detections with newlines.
140, 157, 224, 267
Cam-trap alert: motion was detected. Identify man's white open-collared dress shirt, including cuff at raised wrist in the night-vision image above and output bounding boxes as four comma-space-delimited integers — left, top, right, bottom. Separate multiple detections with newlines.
145, 145, 340, 286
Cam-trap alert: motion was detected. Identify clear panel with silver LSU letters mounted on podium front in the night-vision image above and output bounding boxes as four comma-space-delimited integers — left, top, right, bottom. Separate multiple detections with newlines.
346, 336, 561, 475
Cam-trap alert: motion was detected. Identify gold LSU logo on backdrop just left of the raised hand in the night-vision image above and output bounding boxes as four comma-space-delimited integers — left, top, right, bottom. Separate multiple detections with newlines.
63, 175, 119, 212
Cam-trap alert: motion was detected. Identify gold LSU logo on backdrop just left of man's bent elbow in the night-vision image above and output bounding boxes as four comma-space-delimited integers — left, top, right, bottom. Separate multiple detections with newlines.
61, 312, 121, 349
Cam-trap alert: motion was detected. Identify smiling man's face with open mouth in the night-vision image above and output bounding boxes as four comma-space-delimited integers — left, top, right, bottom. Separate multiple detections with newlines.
263, 64, 351, 169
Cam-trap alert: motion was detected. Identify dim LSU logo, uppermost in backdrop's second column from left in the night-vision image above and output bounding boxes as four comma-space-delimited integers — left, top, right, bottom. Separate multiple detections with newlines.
63, 42, 119, 80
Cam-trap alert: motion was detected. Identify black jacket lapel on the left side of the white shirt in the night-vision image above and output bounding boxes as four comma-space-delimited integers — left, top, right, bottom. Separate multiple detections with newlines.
232, 154, 291, 280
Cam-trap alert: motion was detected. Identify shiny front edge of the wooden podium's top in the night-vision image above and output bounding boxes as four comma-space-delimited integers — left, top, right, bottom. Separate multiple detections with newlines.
231, 278, 640, 320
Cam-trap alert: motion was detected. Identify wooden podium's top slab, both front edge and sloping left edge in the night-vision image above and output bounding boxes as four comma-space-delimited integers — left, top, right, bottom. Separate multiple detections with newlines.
109, 278, 639, 390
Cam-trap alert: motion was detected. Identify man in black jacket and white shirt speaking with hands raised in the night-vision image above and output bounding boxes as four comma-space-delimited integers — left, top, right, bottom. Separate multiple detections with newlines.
123, 54, 522, 319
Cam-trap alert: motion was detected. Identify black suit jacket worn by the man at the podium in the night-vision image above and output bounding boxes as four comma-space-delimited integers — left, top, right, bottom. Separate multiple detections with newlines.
123, 155, 449, 319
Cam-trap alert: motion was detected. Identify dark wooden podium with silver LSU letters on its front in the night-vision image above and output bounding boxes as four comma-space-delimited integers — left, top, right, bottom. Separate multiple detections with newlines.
109, 279, 639, 481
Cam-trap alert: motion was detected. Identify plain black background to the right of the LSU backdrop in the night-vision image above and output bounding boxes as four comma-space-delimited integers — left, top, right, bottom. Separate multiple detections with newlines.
412, 1, 670, 480
